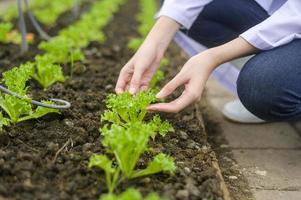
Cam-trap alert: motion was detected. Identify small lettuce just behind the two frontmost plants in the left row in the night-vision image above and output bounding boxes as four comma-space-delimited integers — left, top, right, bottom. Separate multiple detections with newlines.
32, 54, 65, 89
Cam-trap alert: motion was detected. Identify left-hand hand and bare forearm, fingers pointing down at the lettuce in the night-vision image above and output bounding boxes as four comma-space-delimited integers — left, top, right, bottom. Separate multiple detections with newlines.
115, 16, 180, 94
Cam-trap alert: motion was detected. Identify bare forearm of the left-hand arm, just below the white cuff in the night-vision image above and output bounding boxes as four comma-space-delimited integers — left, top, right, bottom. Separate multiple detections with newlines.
145, 16, 180, 54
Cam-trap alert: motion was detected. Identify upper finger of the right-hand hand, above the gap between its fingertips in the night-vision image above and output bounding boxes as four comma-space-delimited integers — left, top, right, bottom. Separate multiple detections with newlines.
156, 74, 187, 99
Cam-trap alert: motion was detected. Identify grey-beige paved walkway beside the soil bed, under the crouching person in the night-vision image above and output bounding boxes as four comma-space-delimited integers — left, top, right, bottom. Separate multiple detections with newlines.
206, 79, 301, 200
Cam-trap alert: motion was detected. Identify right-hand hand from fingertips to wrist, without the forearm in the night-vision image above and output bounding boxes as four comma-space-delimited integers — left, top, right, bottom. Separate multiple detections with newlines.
148, 51, 218, 113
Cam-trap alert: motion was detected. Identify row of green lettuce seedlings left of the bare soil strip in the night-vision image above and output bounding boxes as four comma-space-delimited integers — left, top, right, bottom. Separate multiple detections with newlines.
0, 0, 124, 128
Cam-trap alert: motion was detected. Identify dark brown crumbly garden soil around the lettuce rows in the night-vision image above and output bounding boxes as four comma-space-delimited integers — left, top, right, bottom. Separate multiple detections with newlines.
0, 1, 222, 200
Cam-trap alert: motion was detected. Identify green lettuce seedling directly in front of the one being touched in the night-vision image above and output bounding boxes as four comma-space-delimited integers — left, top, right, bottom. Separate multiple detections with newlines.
89, 122, 176, 193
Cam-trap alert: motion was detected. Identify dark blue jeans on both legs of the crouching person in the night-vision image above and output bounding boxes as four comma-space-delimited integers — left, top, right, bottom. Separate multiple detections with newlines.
175, 0, 301, 121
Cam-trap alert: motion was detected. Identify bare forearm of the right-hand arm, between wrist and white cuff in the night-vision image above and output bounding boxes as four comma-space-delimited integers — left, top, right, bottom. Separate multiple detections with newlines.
206, 37, 259, 67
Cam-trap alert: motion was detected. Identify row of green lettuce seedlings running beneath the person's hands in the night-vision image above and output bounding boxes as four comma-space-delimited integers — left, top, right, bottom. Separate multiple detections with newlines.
89, 0, 176, 197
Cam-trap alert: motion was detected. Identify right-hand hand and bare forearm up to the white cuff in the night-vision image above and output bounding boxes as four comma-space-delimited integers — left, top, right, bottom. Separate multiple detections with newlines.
148, 37, 258, 112
